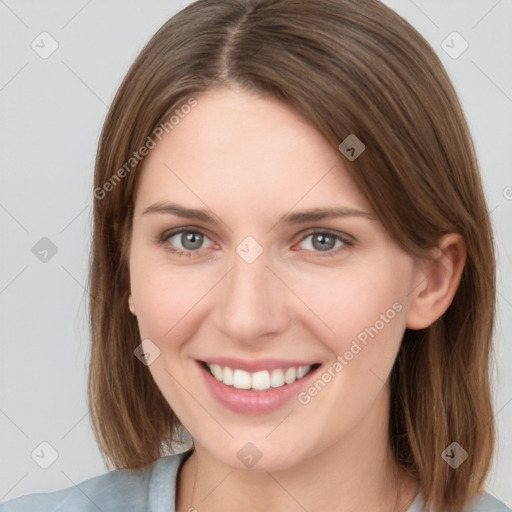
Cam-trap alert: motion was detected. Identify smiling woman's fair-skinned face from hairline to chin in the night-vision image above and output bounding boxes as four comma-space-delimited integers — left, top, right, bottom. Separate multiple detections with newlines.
129, 85, 424, 470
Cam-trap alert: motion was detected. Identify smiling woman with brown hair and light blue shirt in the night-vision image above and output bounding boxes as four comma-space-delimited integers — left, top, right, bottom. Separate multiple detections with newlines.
0, 0, 508, 512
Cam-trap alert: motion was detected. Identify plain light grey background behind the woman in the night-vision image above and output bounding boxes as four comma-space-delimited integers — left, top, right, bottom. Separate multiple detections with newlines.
0, 0, 512, 506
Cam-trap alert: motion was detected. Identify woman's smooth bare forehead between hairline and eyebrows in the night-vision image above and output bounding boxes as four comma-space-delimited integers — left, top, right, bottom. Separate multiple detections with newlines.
136, 88, 369, 216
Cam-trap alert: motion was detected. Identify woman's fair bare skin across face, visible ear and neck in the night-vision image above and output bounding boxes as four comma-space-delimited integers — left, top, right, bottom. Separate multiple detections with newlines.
129, 87, 465, 511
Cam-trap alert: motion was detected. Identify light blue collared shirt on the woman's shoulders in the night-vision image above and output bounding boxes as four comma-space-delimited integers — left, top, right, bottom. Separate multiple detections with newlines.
0, 450, 511, 512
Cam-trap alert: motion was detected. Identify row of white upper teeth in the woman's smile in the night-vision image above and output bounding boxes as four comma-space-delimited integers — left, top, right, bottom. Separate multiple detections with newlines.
207, 364, 311, 391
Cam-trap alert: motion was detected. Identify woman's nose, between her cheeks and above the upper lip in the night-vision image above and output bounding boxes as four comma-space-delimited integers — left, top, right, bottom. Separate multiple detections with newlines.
215, 247, 289, 344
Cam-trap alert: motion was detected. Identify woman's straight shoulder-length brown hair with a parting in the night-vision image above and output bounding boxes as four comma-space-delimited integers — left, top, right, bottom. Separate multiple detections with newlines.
88, 0, 495, 511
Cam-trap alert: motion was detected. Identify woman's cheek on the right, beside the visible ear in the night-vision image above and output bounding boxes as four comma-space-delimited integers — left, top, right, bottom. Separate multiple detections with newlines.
294, 261, 408, 366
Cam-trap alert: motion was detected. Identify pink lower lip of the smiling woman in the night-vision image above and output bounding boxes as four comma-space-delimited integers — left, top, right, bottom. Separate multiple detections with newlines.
196, 361, 320, 414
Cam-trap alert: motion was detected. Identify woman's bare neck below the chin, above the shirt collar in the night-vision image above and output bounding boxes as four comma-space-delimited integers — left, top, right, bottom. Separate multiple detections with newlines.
176, 390, 418, 512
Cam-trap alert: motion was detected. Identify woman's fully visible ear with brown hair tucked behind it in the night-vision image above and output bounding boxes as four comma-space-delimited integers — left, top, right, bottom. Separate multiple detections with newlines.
406, 233, 466, 329
